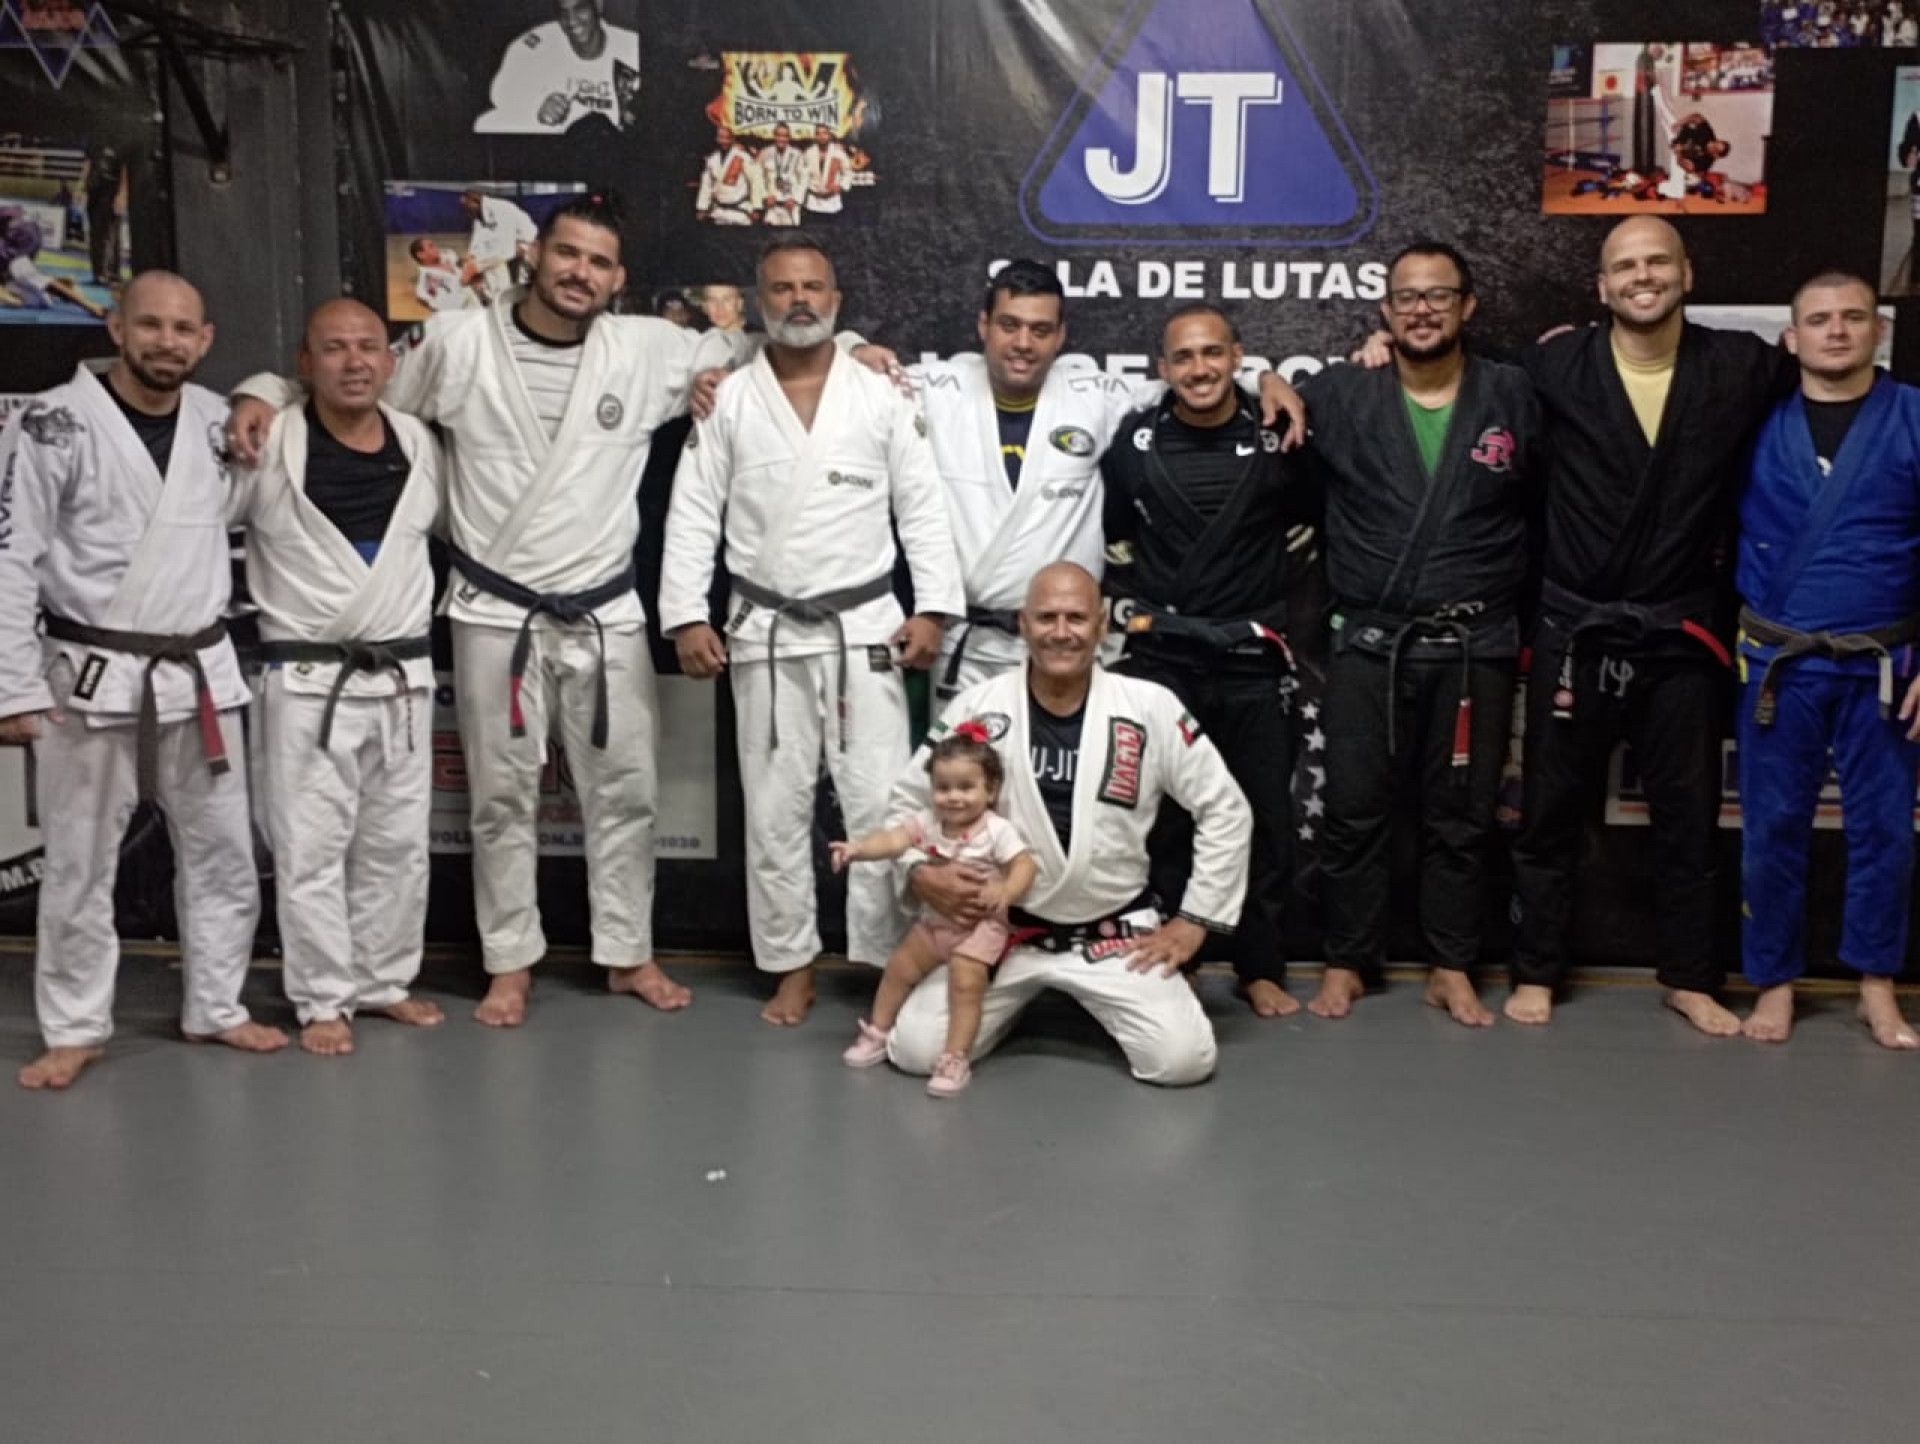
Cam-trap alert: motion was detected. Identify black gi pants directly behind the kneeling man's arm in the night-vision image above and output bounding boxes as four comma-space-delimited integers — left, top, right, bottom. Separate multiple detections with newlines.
1114, 643, 1294, 983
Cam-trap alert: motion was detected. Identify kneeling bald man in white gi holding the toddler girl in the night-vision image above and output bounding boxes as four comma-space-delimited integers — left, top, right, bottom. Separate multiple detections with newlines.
887, 563, 1254, 1087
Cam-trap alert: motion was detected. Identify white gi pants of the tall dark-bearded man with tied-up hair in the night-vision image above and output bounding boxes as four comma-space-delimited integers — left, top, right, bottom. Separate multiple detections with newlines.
453, 618, 659, 974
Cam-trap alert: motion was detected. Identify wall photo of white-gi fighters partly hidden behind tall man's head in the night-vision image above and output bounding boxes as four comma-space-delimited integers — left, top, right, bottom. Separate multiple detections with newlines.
386, 181, 586, 321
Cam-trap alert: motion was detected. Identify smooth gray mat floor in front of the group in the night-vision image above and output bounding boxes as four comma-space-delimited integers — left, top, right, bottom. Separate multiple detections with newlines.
0, 956, 1920, 1444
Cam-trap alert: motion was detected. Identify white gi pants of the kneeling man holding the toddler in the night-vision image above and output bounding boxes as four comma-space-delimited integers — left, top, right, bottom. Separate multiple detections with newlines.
887, 947, 1219, 1087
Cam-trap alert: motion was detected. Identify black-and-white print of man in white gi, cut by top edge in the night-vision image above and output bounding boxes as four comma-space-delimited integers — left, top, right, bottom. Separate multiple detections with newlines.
474, 0, 639, 136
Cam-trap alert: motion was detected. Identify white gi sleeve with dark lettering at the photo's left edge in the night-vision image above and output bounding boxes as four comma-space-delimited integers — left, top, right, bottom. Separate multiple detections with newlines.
0, 414, 60, 716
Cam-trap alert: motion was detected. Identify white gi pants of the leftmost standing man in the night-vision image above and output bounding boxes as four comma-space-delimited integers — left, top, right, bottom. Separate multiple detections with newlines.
33, 666, 259, 1048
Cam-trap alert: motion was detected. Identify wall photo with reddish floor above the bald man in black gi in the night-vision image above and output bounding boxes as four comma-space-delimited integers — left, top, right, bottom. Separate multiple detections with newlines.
1540, 40, 1774, 215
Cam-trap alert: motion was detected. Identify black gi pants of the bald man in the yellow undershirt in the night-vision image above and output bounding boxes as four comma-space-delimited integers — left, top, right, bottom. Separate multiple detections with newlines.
1513, 630, 1728, 993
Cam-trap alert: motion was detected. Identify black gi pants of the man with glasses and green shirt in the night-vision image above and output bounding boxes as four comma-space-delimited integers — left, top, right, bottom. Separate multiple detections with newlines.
1321, 641, 1515, 987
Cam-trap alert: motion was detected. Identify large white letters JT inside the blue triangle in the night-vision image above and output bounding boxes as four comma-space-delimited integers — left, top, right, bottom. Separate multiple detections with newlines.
1085, 71, 1286, 205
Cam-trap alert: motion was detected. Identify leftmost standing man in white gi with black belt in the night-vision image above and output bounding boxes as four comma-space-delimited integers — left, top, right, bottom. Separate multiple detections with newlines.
0, 271, 286, 1089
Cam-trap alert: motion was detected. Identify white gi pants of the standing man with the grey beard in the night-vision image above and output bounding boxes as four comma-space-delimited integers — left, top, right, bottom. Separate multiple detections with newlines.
728, 647, 912, 974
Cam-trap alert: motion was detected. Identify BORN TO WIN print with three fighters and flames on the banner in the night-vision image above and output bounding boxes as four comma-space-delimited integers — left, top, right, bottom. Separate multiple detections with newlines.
691, 50, 879, 227
